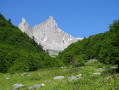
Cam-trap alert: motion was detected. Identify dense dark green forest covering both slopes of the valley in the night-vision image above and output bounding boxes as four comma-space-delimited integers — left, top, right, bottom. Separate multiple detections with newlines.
0, 14, 119, 73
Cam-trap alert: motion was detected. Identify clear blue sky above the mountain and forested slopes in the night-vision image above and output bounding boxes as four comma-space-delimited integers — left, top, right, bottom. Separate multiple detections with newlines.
0, 0, 119, 37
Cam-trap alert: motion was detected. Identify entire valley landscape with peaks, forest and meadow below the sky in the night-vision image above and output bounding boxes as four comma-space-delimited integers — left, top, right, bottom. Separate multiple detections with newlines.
0, 14, 119, 90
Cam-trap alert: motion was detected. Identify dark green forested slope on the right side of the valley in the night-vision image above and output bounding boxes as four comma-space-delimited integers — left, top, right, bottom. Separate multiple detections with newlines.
56, 20, 119, 67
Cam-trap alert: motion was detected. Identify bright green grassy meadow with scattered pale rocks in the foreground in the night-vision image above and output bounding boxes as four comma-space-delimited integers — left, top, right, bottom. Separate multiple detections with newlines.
0, 59, 119, 90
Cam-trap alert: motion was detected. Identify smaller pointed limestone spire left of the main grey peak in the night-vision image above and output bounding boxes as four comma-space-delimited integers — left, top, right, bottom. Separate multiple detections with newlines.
18, 18, 30, 32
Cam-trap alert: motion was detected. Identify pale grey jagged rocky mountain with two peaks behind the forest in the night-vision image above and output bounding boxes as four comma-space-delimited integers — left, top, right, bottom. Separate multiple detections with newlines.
18, 16, 82, 54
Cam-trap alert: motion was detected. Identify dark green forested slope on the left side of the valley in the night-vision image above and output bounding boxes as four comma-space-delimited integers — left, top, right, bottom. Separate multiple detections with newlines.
0, 14, 62, 73
